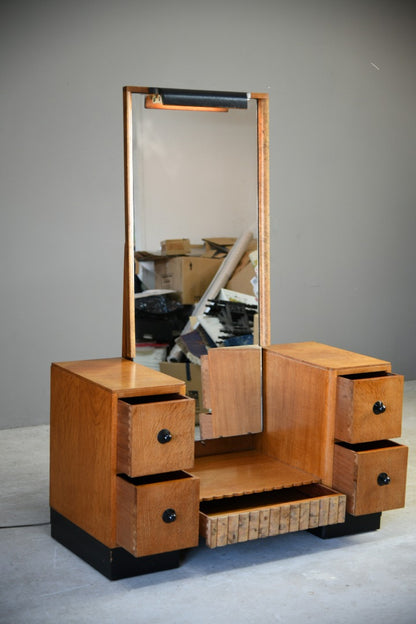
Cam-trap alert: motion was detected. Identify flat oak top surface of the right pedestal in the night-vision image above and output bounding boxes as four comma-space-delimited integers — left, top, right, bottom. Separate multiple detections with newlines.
267, 342, 391, 375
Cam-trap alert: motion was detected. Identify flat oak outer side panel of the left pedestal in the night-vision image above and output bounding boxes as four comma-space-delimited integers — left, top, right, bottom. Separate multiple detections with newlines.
50, 365, 117, 548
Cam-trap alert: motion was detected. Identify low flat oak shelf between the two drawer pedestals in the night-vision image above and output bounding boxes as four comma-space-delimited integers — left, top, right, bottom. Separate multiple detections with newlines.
191, 451, 319, 500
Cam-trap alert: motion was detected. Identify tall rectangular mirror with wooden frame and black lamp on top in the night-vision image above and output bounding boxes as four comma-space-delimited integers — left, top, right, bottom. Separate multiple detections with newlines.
122, 87, 270, 390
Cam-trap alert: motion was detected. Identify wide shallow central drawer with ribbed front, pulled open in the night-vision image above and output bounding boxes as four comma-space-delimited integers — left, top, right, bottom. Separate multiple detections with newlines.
199, 484, 346, 548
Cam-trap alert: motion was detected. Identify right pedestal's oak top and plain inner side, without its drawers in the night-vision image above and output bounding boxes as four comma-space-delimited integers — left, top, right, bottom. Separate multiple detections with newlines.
259, 342, 391, 486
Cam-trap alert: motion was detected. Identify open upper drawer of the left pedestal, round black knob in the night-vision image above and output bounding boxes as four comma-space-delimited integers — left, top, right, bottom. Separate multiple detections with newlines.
117, 395, 195, 477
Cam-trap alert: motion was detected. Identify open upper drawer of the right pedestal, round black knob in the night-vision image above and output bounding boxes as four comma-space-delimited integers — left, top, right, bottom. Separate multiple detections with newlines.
335, 373, 403, 444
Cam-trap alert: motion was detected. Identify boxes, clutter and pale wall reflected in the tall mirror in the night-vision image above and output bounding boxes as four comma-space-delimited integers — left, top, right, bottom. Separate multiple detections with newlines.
131, 93, 259, 382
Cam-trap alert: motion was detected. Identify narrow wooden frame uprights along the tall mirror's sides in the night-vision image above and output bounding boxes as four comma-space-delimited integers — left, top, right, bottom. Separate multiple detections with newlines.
122, 86, 270, 360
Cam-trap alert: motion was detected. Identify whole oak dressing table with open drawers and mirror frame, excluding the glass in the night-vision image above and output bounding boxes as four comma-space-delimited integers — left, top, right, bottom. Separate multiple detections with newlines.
50, 87, 407, 579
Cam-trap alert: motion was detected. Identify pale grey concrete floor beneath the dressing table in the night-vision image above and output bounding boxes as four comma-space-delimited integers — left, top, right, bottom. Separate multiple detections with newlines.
0, 381, 416, 624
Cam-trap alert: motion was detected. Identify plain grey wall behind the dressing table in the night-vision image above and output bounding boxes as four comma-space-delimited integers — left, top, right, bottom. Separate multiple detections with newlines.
0, 0, 416, 427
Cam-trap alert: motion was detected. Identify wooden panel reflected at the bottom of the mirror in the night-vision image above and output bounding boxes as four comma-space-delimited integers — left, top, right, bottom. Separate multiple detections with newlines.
204, 347, 262, 438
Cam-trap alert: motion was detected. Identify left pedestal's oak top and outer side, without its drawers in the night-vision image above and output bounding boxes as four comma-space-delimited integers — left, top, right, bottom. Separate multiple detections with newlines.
50, 358, 185, 548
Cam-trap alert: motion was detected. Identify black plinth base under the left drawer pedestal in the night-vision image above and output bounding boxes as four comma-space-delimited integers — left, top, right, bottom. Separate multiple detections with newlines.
51, 508, 181, 581
